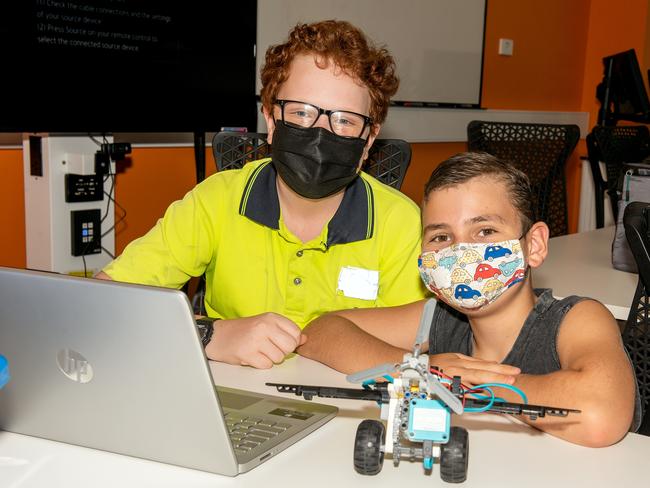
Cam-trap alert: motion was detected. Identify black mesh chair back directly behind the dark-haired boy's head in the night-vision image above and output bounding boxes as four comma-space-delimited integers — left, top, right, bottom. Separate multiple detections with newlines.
467, 120, 580, 237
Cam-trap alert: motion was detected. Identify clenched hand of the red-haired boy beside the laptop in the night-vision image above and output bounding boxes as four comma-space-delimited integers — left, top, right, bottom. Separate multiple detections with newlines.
205, 312, 307, 369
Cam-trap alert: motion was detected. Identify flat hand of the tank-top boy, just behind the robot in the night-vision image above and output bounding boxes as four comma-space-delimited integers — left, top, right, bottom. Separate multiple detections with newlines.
429, 352, 521, 386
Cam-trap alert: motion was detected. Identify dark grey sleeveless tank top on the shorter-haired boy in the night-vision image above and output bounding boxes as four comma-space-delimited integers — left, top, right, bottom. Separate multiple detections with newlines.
429, 289, 643, 431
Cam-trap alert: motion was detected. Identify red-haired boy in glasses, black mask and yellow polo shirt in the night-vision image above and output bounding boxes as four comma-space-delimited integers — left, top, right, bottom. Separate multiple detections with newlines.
97, 20, 426, 368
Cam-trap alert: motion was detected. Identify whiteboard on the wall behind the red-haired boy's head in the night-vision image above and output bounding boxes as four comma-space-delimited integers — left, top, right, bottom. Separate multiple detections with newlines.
256, 0, 486, 108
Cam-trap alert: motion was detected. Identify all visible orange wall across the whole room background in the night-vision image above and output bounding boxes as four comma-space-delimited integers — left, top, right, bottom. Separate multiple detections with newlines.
0, 0, 650, 266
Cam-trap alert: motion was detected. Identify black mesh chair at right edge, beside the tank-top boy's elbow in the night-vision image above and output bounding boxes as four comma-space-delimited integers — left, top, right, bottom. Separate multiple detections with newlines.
623, 202, 650, 435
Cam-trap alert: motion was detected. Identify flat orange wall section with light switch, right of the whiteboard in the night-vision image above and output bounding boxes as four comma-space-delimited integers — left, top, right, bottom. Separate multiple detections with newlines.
482, 0, 590, 111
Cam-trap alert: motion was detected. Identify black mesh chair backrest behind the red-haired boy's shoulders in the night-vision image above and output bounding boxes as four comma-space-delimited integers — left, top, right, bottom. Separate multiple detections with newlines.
212, 132, 411, 190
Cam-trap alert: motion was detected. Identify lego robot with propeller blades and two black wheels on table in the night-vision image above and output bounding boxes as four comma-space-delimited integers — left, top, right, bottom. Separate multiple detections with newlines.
266, 300, 580, 483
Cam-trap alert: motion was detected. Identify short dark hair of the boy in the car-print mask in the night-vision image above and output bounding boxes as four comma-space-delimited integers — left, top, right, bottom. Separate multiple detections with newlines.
424, 152, 537, 234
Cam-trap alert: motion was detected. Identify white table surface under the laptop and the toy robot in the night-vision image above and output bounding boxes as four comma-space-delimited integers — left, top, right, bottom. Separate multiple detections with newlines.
0, 357, 650, 488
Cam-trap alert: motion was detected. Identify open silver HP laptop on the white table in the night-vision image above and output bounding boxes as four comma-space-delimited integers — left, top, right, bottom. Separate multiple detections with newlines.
0, 268, 337, 476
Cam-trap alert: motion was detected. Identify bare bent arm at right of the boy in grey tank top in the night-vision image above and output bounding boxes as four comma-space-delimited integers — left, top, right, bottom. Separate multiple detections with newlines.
497, 300, 635, 447
